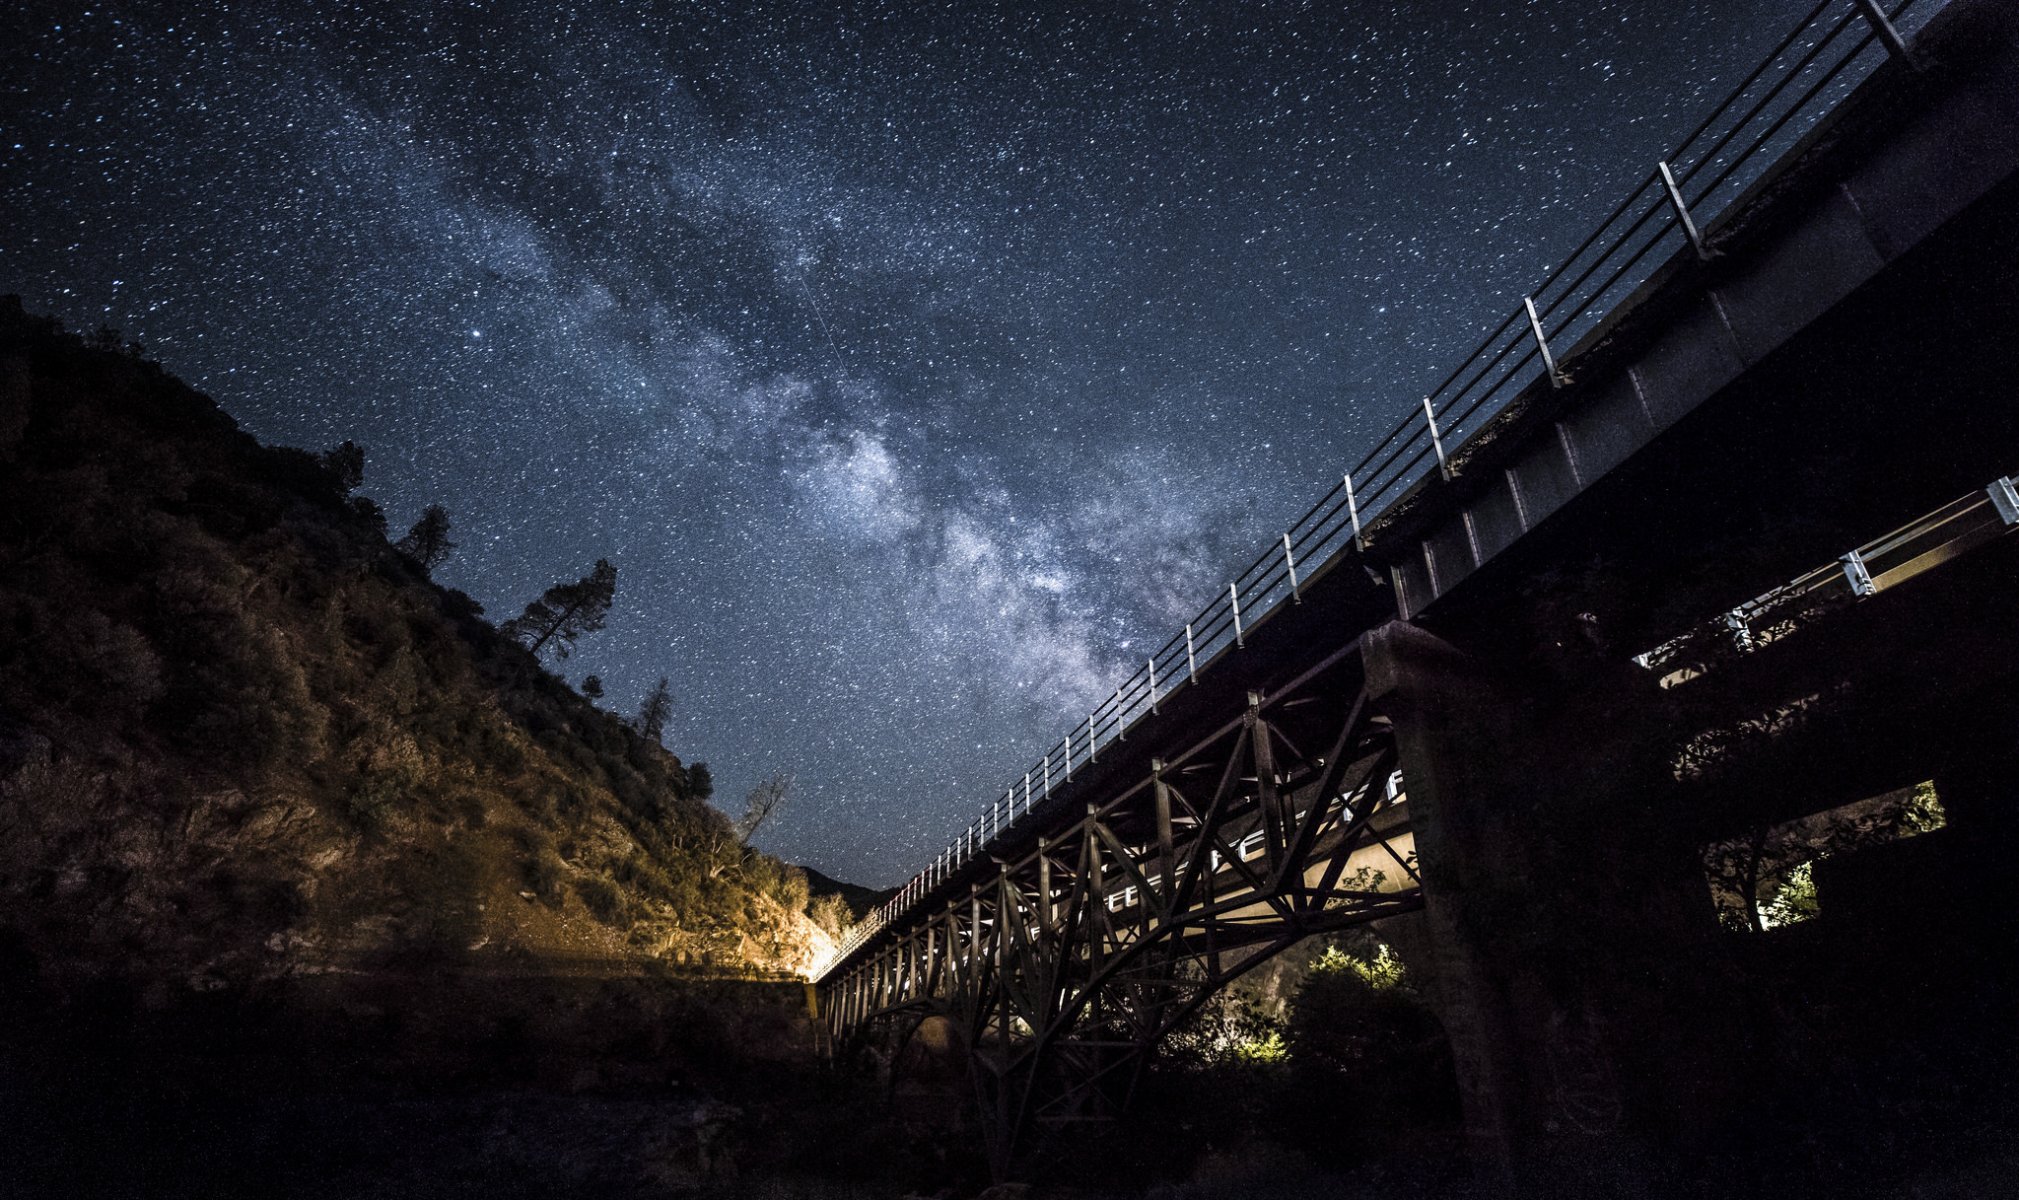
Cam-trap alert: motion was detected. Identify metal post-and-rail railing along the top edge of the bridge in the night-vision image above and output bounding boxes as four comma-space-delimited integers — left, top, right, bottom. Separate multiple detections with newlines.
836, 0, 1940, 962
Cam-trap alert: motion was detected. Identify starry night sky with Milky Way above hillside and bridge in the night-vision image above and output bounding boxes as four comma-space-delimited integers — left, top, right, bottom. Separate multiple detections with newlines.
0, 0, 1807, 885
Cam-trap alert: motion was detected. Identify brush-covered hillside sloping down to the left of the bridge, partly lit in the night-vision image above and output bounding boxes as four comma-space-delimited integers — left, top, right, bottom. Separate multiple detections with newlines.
0, 299, 836, 998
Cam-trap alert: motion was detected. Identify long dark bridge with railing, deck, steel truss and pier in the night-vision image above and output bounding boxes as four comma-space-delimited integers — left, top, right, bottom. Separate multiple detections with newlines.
818, 0, 2019, 1174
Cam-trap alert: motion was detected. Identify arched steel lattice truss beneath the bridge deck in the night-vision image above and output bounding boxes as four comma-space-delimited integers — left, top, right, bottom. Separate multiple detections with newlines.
822, 640, 1421, 1168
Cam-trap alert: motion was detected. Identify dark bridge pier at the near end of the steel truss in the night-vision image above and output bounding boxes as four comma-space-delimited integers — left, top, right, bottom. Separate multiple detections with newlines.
1363, 622, 1744, 1188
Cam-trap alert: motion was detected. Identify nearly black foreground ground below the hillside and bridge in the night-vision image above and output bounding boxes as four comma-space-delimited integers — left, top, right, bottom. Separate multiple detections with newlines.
0, 933, 2019, 1200
